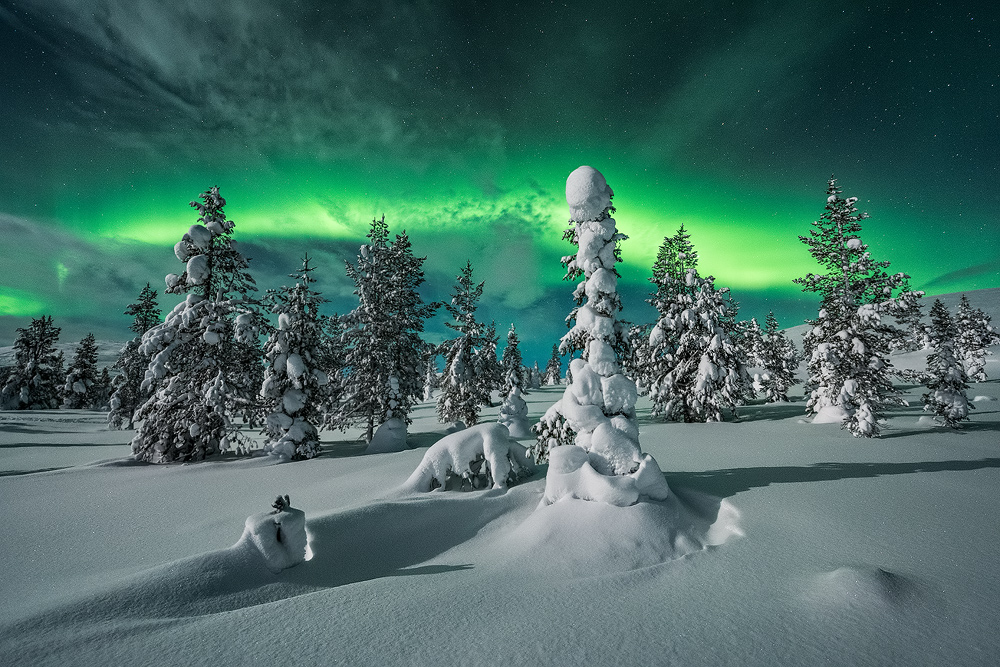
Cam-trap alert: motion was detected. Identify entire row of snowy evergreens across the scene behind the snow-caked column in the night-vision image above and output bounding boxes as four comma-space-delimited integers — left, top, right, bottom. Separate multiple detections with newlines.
0, 178, 998, 452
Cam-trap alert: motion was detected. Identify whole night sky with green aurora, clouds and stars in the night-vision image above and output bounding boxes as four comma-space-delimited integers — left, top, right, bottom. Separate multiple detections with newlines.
0, 0, 1000, 366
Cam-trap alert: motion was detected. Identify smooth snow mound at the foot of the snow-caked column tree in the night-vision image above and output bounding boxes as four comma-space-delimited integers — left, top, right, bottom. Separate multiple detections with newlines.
504, 494, 743, 577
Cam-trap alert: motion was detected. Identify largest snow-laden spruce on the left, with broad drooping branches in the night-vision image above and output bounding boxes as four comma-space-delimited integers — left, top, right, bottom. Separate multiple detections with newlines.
132, 187, 260, 463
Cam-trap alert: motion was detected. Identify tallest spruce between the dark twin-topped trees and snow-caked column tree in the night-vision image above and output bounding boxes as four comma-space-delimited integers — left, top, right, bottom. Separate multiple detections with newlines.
437, 262, 496, 426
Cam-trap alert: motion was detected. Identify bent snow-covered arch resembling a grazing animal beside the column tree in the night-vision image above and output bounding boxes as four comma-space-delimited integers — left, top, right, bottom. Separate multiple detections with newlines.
403, 422, 534, 492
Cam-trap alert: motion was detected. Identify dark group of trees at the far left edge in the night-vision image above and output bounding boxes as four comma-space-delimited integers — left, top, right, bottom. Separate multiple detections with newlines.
0, 315, 112, 410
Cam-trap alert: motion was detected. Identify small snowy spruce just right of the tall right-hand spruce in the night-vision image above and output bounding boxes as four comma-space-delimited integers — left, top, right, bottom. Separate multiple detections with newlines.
922, 299, 975, 428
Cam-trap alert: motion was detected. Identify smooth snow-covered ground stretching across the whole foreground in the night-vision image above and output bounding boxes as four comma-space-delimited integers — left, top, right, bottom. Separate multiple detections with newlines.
0, 354, 1000, 666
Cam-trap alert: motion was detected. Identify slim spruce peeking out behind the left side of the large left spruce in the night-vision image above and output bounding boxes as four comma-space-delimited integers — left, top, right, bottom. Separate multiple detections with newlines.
108, 283, 160, 430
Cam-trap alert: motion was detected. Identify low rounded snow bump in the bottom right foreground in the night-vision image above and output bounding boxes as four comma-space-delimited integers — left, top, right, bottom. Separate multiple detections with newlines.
808, 565, 918, 610
